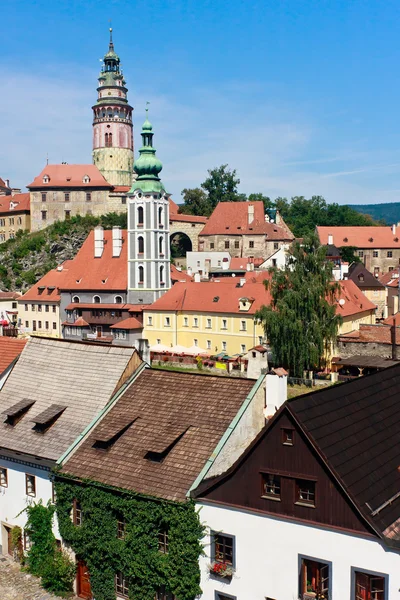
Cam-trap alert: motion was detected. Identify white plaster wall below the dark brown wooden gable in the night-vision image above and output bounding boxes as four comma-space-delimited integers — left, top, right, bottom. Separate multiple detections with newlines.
198, 503, 400, 600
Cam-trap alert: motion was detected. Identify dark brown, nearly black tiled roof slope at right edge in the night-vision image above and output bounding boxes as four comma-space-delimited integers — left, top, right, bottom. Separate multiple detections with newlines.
287, 365, 400, 532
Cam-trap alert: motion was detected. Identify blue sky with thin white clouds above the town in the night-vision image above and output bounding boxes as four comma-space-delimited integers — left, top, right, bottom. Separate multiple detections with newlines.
0, 0, 400, 203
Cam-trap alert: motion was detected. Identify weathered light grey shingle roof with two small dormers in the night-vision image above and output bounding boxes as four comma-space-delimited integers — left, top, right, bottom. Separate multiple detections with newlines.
0, 337, 140, 460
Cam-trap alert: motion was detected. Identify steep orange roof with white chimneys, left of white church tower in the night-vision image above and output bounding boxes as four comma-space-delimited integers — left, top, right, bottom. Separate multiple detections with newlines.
62, 229, 128, 294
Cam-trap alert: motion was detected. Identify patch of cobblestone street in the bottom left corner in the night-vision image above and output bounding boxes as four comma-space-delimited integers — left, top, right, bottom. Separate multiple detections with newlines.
0, 557, 77, 600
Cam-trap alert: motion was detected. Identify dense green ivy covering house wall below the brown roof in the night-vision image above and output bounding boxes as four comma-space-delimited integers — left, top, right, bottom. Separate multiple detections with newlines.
55, 478, 204, 600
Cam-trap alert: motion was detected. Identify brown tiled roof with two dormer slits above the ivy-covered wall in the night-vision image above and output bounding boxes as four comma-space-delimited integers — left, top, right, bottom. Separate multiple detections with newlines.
61, 369, 254, 501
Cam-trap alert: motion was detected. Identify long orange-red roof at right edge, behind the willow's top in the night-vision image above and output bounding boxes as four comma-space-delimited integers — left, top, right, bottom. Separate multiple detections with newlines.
317, 226, 400, 248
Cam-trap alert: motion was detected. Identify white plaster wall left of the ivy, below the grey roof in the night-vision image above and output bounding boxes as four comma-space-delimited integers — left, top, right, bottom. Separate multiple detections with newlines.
0, 457, 60, 552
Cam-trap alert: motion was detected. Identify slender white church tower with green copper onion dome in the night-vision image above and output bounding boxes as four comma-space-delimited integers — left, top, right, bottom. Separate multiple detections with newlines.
128, 109, 171, 304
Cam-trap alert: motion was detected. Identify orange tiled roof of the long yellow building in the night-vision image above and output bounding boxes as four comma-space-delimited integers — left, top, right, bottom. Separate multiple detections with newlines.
147, 278, 271, 316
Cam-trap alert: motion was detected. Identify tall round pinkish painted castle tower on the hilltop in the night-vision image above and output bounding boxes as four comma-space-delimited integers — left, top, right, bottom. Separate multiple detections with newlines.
92, 28, 133, 186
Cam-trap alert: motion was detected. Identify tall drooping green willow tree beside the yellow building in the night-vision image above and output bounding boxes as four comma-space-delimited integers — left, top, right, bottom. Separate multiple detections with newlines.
255, 236, 341, 377
